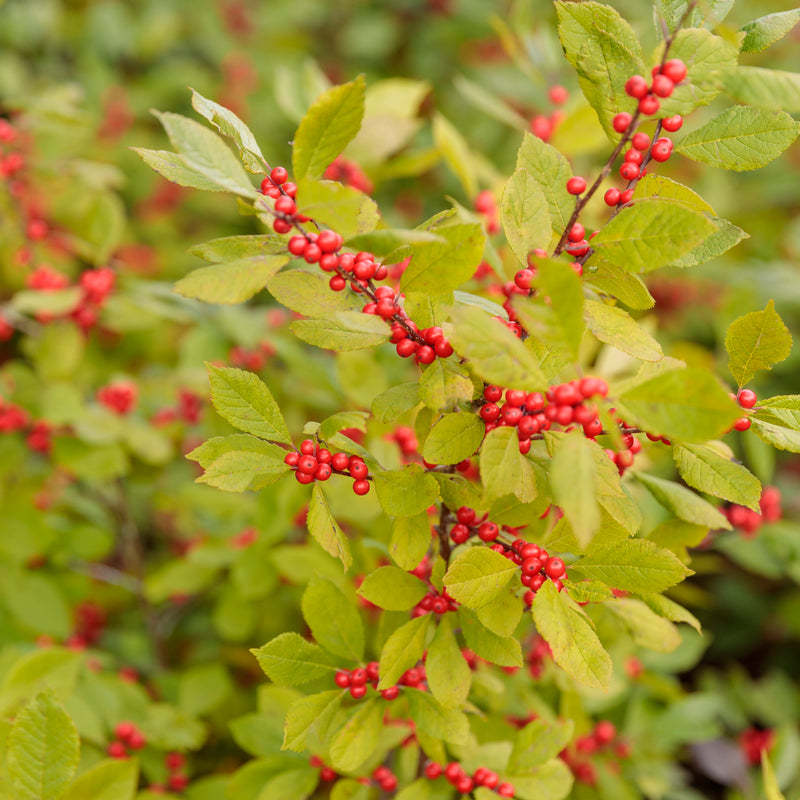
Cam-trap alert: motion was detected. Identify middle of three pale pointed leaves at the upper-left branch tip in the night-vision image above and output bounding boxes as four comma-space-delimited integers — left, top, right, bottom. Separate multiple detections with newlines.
153, 111, 258, 199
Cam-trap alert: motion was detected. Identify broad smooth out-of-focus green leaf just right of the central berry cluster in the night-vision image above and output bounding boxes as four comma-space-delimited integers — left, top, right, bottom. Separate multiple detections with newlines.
618, 369, 741, 442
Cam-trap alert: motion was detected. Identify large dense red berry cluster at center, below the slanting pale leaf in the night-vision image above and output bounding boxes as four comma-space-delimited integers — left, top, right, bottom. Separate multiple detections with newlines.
479, 377, 608, 453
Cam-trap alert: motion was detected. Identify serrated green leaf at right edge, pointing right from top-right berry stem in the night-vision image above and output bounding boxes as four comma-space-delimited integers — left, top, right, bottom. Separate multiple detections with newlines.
676, 106, 800, 171
